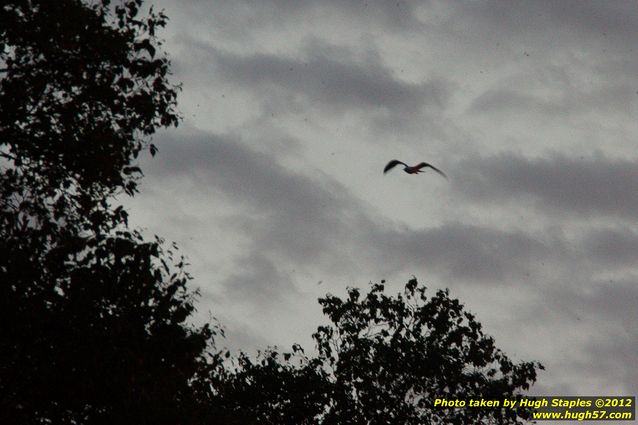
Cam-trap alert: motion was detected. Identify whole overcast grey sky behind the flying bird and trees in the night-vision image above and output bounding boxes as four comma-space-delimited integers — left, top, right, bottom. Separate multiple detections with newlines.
127, 0, 638, 410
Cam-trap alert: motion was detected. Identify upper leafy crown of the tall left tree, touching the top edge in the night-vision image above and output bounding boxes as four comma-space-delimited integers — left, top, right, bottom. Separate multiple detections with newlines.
0, 0, 177, 194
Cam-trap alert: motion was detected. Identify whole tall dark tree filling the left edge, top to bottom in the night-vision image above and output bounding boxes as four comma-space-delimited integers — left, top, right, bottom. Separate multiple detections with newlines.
0, 0, 214, 424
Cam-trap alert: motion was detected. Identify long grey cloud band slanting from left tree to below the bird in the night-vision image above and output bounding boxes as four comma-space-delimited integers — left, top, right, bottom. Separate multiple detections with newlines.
142, 129, 565, 295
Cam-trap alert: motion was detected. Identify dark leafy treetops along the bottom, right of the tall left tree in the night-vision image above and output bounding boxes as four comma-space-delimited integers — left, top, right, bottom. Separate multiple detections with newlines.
211, 279, 542, 425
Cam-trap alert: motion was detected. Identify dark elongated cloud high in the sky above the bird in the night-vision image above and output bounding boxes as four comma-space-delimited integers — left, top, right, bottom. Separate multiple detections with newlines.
211, 46, 448, 113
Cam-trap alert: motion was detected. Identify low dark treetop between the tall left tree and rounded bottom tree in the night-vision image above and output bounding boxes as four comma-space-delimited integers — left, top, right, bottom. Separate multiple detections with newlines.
204, 345, 331, 425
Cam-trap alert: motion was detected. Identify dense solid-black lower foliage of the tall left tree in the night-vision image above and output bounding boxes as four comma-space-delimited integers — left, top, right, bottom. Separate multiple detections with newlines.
0, 232, 212, 424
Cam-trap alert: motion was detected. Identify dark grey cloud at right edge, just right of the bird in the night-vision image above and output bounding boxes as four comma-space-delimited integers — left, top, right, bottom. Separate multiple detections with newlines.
454, 153, 638, 219
